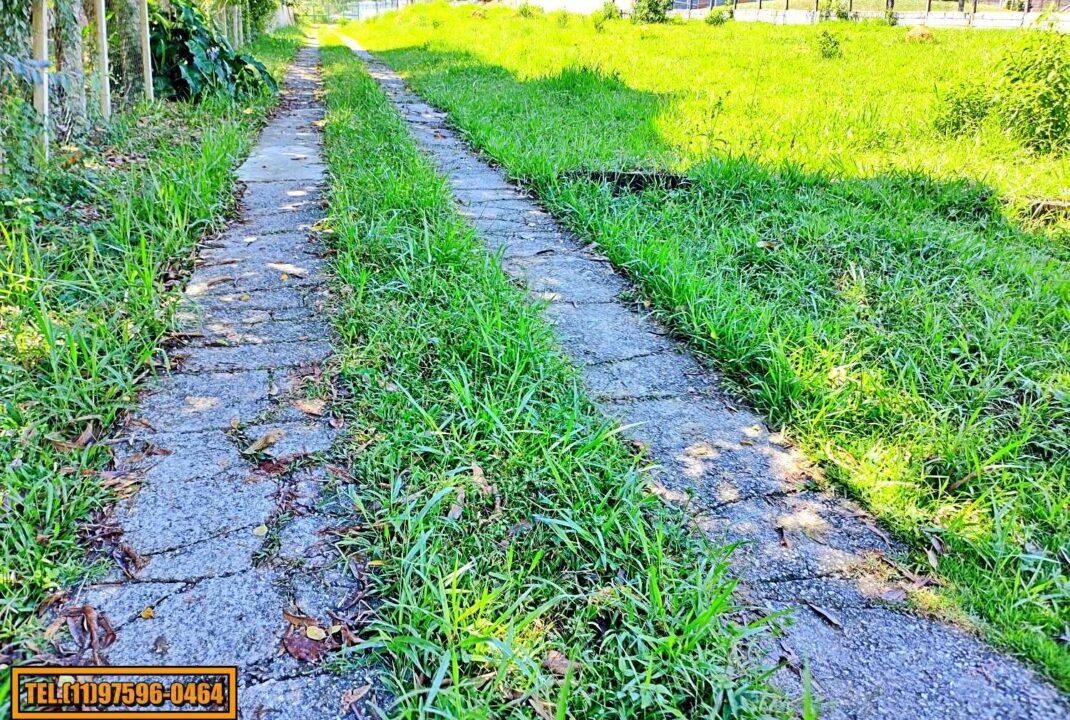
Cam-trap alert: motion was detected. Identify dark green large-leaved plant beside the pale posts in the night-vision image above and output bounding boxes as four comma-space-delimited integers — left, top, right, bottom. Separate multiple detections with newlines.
151, 0, 278, 99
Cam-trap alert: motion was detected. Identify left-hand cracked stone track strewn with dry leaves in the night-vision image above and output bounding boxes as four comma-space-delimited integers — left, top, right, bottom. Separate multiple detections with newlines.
71, 42, 384, 720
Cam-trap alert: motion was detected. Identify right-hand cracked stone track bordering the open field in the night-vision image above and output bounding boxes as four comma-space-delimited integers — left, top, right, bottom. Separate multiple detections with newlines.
342, 37, 1070, 720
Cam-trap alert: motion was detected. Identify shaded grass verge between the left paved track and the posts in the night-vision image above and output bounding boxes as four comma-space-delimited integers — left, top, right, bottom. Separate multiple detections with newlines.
0, 30, 301, 663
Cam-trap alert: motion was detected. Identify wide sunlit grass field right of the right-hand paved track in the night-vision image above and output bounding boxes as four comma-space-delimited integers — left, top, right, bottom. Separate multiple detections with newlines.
345, 4, 1070, 690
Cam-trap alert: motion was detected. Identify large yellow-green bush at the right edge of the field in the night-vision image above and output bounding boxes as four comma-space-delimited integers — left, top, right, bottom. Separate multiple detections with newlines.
994, 30, 1070, 152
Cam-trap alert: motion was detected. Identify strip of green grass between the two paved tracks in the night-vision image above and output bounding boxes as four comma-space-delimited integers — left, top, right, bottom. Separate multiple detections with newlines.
314, 33, 780, 720
